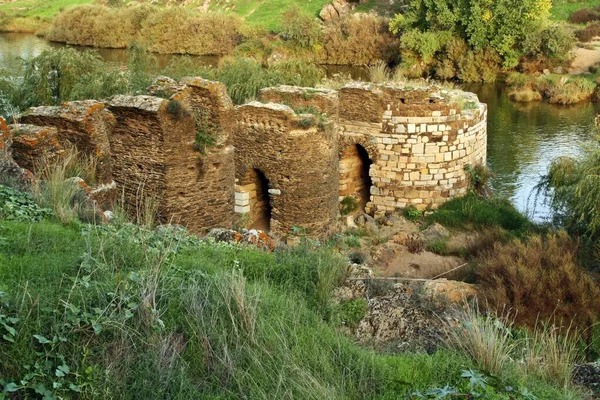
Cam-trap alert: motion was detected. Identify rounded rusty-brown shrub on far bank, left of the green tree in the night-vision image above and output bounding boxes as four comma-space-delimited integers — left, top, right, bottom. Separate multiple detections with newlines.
317, 14, 396, 65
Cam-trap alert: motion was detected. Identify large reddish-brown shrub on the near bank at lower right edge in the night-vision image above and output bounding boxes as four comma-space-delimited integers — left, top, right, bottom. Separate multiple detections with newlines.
476, 232, 600, 333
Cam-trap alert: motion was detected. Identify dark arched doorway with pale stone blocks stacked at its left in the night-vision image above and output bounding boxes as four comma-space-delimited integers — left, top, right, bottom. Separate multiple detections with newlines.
239, 169, 271, 232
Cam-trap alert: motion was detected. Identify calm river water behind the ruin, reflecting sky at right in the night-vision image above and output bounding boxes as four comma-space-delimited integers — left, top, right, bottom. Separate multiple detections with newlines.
0, 34, 600, 221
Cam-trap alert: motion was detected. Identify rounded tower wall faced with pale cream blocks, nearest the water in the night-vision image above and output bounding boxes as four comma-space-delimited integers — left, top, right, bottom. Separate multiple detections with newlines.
339, 84, 487, 212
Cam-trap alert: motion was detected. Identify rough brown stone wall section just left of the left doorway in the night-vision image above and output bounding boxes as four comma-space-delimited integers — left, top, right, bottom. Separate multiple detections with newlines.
109, 96, 234, 233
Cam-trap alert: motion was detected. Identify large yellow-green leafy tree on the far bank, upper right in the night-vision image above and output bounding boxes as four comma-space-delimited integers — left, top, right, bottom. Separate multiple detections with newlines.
389, 0, 574, 81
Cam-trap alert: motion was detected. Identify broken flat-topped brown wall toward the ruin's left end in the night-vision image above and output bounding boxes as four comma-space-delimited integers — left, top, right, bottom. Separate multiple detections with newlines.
20, 100, 115, 183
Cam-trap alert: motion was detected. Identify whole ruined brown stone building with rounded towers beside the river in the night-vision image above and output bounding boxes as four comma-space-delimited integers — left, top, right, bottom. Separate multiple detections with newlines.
0, 78, 487, 236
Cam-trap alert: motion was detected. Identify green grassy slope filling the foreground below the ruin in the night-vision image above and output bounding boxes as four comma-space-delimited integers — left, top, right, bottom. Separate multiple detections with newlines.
0, 220, 573, 399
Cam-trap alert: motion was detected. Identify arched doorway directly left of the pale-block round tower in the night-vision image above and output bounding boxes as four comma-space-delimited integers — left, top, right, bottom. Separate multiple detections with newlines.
339, 144, 373, 211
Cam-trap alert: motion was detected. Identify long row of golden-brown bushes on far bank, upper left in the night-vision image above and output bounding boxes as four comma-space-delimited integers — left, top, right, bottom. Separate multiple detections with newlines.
48, 5, 241, 55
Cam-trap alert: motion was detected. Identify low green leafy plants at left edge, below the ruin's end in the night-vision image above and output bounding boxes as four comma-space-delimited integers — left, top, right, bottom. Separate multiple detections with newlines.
0, 185, 52, 222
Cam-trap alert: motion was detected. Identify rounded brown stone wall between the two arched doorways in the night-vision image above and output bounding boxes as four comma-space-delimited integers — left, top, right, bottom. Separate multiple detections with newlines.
234, 102, 339, 235
